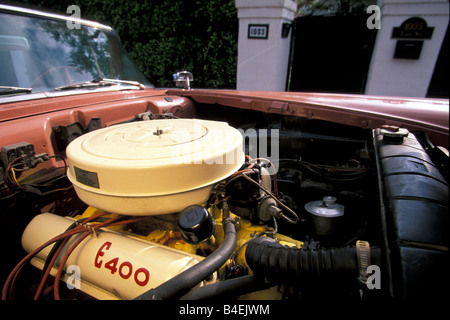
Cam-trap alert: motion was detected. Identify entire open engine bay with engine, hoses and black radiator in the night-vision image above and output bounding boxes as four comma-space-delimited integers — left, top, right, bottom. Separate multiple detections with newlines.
0, 95, 449, 301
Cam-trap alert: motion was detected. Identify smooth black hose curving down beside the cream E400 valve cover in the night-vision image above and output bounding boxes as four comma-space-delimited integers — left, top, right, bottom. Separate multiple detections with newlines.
134, 219, 236, 300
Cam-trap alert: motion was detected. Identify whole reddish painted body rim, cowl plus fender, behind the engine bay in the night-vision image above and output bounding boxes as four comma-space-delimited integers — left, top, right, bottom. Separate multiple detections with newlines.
0, 89, 449, 148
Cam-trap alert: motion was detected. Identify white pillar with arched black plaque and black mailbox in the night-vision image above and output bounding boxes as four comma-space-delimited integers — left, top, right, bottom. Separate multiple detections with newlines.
365, 0, 449, 97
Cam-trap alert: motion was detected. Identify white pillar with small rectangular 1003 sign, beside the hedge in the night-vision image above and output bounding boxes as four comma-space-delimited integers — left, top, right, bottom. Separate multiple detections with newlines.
236, 0, 297, 91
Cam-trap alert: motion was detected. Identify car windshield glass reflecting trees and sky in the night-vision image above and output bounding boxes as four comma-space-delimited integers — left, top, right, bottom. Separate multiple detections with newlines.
0, 12, 151, 92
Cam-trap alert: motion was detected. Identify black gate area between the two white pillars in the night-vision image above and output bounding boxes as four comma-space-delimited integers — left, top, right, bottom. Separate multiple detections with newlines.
287, 14, 377, 94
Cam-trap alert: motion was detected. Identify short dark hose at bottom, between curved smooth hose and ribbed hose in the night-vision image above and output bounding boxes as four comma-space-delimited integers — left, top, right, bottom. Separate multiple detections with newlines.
180, 274, 273, 300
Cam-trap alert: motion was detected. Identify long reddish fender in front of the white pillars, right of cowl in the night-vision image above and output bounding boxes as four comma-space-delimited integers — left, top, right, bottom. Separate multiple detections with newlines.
168, 89, 449, 148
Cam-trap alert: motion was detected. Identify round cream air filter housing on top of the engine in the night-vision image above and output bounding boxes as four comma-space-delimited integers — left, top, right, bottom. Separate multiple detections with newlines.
66, 119, 245, 215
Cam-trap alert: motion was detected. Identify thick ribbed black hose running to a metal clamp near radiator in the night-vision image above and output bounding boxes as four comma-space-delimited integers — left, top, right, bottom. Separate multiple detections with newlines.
245, 237, 380, 280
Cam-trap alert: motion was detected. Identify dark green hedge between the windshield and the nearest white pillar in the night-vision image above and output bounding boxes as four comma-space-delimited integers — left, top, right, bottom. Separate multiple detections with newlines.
20, 0, 238, 88
